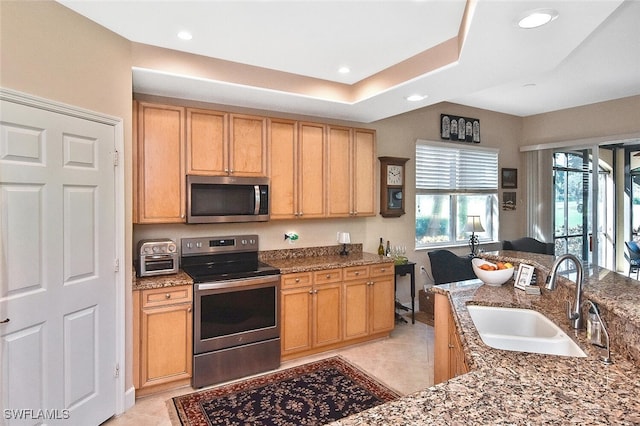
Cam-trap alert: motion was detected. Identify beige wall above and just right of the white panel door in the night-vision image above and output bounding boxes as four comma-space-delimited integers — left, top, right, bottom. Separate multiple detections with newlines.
0, 1, 133, 388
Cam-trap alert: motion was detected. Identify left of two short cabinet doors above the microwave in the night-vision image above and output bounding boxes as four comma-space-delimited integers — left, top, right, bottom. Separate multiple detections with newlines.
187, 108, 229, 176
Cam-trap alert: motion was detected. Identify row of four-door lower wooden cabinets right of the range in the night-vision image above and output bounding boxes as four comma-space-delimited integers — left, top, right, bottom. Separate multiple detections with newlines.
280, 263, 395, 360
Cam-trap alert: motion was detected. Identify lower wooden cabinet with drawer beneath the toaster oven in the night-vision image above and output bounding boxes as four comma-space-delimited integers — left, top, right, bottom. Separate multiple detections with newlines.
133, 285, 193, 397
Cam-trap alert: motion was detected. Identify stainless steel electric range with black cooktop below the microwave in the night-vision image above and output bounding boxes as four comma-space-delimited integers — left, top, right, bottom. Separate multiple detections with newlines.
181, 235, 280, 388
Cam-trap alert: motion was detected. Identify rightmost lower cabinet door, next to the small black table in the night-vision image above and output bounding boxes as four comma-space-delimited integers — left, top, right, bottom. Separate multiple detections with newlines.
369, 275, 395, 334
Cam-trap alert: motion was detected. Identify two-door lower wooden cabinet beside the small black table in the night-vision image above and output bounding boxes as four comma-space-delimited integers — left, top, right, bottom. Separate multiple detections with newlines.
343, 264, 395, 340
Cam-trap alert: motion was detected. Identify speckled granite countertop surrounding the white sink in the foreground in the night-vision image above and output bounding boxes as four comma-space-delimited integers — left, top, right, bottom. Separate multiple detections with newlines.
333, 251, 640, 425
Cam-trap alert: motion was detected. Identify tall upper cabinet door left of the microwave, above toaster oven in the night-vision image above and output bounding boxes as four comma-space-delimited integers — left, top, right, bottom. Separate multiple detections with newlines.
134, 102, 185, 223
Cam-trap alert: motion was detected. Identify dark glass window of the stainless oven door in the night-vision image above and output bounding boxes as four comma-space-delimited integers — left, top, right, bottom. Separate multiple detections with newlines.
200, 287, 277, 341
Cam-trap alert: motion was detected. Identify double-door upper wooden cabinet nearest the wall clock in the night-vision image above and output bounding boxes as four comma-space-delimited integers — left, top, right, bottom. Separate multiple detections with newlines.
327, 126, 375, 217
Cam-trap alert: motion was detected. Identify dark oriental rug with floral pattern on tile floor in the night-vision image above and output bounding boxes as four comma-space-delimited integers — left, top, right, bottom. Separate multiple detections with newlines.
172, 356, 400, 426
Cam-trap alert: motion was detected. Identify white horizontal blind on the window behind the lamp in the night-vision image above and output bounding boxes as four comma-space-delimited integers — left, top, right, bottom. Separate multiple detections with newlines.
416, 141, 498, 192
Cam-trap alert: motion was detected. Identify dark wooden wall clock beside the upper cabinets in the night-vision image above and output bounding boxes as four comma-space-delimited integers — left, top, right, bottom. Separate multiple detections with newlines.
378, 157, 409, 217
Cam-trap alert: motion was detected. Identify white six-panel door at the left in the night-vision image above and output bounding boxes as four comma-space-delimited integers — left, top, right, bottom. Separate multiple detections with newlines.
0, 101, 116, 425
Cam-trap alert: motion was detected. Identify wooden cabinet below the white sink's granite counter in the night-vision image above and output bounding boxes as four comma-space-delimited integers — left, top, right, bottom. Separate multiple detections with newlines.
433, 293, 469, 384
